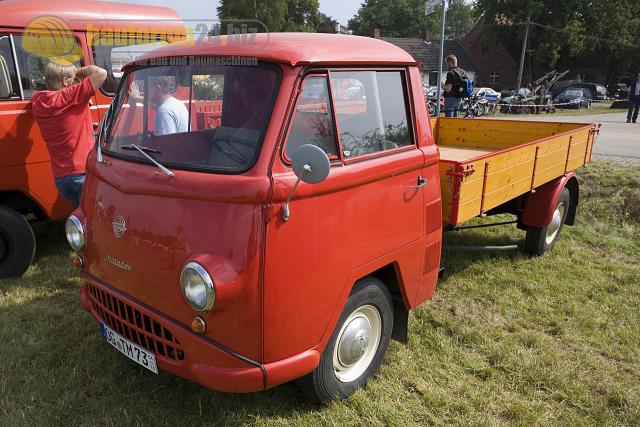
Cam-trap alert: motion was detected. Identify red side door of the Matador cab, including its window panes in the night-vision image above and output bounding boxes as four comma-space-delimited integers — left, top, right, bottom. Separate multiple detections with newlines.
264, 70, 426, 362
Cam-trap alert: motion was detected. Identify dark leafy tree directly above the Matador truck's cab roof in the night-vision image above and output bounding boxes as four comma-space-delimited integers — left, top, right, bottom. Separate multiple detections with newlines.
218, 0, 320, 32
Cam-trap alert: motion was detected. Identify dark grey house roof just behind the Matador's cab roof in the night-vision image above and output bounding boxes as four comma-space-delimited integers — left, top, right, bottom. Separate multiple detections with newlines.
381, 37, 480, 71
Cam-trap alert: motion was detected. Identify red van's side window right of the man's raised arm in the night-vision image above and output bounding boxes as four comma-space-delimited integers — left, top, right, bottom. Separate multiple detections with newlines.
93, 37, 166, 96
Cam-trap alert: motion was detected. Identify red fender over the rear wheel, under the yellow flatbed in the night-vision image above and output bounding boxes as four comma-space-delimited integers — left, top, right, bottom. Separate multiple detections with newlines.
520, 172, 579, 227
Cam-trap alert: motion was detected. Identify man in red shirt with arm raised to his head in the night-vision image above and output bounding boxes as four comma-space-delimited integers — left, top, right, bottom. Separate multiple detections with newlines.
32, 62, 107, 209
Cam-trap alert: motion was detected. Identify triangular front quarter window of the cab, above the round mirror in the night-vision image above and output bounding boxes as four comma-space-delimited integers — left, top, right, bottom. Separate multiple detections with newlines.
286, 76, 338, 159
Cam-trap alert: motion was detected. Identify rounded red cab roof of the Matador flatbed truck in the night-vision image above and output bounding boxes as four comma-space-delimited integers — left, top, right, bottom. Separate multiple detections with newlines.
135, 33, 416, 66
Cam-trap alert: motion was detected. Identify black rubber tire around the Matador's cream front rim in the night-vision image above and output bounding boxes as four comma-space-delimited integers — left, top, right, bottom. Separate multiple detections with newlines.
298, 277, 393, 403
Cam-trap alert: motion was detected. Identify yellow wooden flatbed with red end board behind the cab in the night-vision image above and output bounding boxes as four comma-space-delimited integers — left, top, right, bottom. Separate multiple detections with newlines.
431, 118, 599, 226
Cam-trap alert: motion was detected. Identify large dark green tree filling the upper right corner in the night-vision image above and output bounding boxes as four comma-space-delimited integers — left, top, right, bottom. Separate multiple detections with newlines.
476, 0, 640, 80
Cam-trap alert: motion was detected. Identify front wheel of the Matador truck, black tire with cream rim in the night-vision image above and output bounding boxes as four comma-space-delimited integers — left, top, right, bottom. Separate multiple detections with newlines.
299, 278, 393, 403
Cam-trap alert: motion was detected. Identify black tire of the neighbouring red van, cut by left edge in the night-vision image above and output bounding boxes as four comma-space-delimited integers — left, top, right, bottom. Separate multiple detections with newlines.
0, 206, 36, 279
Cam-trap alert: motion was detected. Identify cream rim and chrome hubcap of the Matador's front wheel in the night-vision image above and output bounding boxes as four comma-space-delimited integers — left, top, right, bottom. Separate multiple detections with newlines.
333, 305, 382, 383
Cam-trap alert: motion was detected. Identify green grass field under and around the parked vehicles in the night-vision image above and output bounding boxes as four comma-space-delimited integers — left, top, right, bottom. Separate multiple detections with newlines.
0, 163, 640, 426
